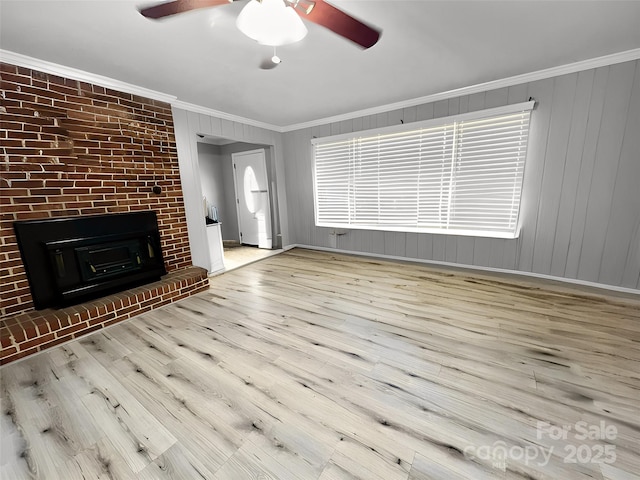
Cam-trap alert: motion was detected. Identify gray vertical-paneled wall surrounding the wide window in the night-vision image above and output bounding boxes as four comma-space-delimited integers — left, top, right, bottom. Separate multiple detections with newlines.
283, 61, 640, 288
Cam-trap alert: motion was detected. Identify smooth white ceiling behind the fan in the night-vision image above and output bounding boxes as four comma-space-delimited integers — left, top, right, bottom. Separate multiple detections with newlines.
0, 0, 640, 127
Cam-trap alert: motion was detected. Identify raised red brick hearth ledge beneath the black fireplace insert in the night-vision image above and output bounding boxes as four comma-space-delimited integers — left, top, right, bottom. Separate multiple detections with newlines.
0, 267, 209, 365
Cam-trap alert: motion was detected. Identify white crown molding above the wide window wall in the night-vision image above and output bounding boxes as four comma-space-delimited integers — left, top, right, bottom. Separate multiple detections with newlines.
280, 48, 640, 133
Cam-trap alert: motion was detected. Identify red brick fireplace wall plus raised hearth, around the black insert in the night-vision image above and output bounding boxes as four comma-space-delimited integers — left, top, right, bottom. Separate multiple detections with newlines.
0, 63, 208, 363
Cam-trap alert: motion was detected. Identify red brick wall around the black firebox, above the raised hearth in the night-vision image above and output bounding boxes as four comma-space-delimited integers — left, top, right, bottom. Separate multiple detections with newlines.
0, 63, 191, 318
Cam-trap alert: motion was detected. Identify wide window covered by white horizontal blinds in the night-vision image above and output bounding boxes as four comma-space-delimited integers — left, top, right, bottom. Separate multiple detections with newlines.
312, 102, 534, 238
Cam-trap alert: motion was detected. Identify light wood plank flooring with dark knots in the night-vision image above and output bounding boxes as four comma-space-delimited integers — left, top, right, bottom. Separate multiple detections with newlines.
0, 249, 640, 480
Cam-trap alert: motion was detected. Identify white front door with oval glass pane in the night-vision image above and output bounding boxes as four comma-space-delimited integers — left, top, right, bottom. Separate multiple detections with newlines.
231, 150, 272, 248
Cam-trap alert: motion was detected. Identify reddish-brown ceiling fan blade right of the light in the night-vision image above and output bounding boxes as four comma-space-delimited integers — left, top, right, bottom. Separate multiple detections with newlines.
296, 0, 381, 48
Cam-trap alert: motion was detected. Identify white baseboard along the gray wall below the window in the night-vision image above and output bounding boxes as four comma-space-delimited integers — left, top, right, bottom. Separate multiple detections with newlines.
283, 243, 640, 296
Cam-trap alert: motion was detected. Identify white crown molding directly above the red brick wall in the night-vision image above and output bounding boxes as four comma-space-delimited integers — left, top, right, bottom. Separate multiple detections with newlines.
0, 50, 176, 103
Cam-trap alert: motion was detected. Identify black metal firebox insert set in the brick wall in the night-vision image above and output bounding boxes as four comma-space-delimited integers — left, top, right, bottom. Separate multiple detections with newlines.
13, 211, 167, 310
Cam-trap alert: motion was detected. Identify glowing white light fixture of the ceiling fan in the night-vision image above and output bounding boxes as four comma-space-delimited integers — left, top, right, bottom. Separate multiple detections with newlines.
236, 0, 307, 47
